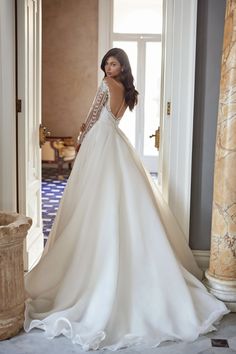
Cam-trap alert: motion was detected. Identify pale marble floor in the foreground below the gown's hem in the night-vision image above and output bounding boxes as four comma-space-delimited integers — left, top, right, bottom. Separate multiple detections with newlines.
0, 313, 236, 354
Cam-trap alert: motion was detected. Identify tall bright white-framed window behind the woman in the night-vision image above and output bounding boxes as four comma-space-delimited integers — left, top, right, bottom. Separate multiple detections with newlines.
111, 0, 163, 172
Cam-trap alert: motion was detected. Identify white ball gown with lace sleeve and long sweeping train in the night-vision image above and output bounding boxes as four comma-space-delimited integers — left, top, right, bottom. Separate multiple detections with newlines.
24, 81, 229, 351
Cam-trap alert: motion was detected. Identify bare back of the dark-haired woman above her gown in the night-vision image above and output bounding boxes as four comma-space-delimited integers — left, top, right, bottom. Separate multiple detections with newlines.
105, 77, 127, 119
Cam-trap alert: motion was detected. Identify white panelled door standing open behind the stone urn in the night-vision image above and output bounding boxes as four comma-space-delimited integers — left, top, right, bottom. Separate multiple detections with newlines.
16, 0, 43, 270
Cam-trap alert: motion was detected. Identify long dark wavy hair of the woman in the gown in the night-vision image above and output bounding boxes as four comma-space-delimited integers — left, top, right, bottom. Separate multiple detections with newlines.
101, 48, 138, 111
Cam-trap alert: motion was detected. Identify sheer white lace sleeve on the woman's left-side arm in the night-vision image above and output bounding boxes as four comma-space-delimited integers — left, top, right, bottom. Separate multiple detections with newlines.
78, 81, 108, 145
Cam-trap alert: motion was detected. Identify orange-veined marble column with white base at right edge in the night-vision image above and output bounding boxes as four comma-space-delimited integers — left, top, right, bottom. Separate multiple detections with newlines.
205, 0, 236, 311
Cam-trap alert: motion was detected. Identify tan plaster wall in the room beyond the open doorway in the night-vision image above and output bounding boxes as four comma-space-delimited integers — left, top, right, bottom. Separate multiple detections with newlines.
42, 0, 98, 141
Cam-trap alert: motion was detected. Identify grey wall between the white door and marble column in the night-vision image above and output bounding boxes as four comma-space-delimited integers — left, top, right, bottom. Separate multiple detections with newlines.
190, 0, 226, 250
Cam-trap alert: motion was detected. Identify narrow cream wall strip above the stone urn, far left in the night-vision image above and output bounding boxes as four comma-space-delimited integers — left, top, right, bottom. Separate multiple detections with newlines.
0, 0, 17, 211
